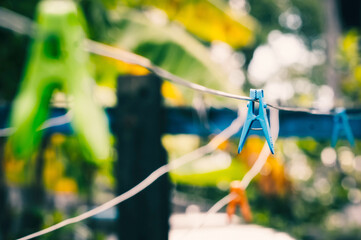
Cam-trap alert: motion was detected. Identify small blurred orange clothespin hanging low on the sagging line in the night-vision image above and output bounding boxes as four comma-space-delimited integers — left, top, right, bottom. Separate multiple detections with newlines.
227, 181, 252, 222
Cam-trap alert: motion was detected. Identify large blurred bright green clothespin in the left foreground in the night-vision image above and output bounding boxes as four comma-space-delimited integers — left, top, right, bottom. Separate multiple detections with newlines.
9, 0, 110, 161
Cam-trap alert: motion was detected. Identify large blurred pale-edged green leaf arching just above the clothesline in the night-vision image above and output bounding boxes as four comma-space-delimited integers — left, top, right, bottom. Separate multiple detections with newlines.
113, 9, 226, 89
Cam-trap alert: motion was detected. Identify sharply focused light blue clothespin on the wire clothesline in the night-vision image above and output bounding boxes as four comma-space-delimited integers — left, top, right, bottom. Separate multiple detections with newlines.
238, 89, 274, 154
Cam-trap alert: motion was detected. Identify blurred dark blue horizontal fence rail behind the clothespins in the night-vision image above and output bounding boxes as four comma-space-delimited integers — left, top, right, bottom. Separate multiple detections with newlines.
0, 106, 361, 140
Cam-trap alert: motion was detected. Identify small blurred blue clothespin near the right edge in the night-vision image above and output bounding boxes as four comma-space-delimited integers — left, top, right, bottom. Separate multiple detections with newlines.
331, 108, 355, 147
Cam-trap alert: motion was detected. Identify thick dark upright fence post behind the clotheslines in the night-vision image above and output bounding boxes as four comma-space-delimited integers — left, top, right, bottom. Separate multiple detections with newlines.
112, 75, 170, 240
